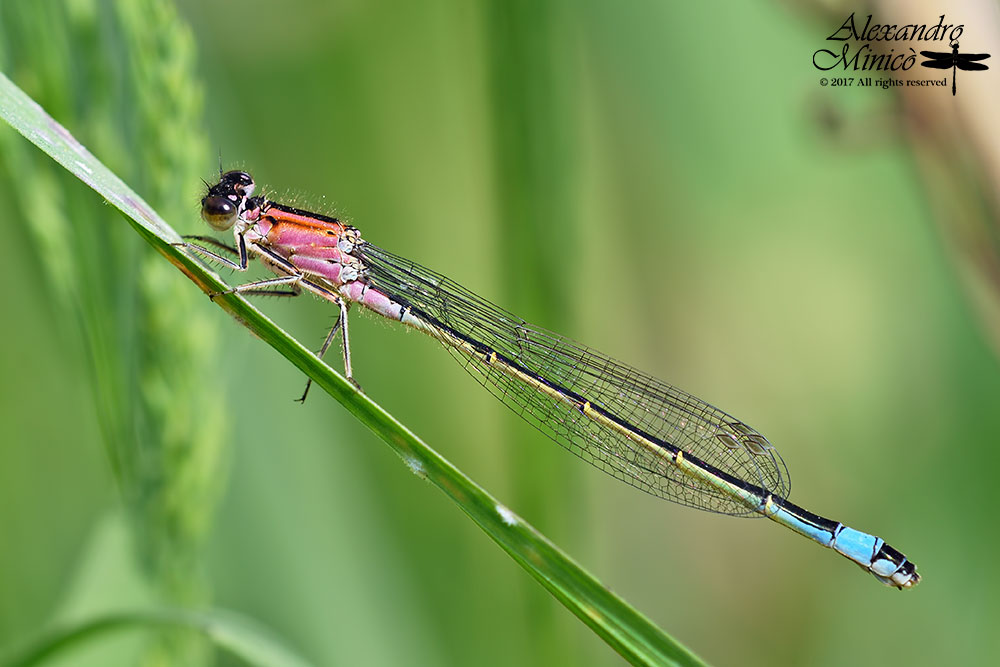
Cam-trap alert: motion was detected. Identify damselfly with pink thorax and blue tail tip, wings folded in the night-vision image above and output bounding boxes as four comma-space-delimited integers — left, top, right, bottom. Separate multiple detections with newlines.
186, 171, 920, 589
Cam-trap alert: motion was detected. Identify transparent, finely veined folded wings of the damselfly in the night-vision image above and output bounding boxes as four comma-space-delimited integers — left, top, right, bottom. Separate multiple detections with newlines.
355, 242, 790, 516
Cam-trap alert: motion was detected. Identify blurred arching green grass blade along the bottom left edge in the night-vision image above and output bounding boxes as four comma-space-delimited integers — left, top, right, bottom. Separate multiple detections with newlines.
0, 609, 310, 667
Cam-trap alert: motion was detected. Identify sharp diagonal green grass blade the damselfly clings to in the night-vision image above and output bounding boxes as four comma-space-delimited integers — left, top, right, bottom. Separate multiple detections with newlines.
0, 74, 703, 665
